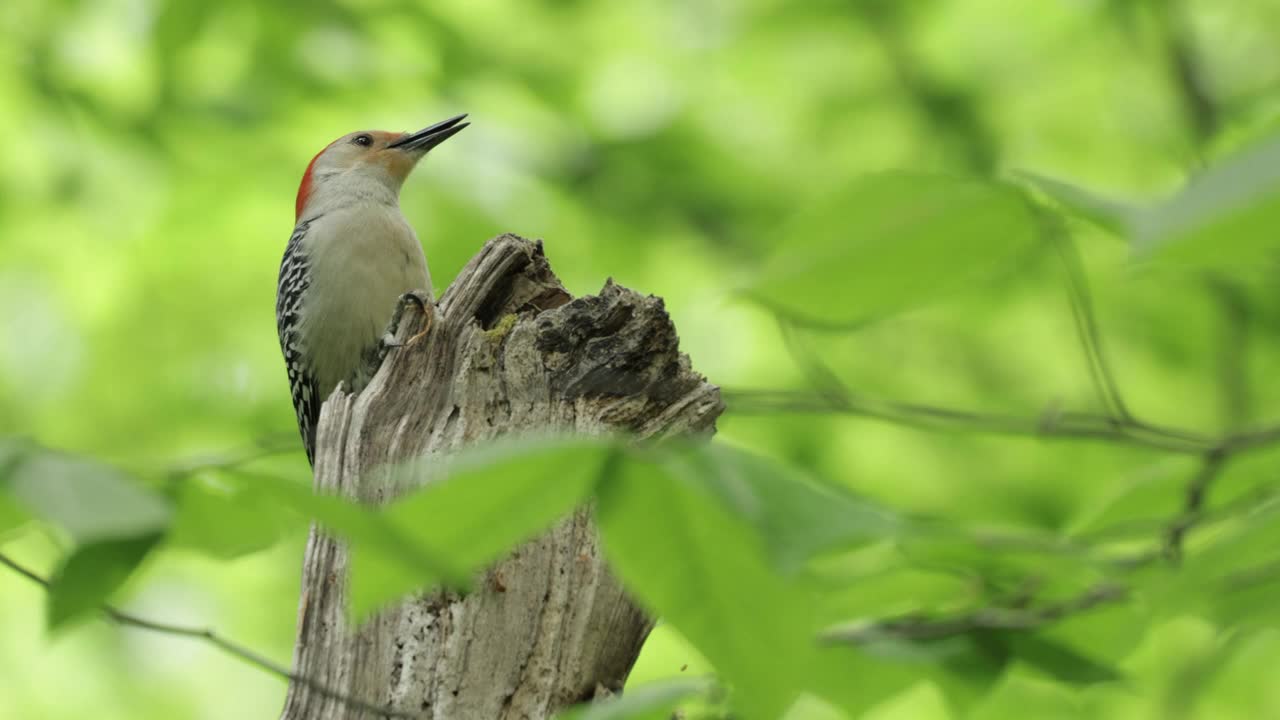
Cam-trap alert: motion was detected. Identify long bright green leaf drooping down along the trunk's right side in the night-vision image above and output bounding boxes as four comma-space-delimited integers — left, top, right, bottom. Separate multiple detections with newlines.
598, 450, 815, 719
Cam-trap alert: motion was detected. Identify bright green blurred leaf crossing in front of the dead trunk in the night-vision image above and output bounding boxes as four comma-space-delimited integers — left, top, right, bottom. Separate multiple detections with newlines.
351, 438, 612, 616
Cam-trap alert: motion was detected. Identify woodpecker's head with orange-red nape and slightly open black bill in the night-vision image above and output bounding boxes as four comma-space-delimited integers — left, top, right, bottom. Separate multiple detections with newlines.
296, 115, 470, 220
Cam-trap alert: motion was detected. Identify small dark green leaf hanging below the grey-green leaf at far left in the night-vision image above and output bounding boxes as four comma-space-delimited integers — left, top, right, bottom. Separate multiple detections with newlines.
47, 533, 160, 630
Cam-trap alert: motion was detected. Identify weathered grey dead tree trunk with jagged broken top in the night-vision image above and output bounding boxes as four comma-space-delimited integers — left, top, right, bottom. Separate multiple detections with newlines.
282, 234, 723, 720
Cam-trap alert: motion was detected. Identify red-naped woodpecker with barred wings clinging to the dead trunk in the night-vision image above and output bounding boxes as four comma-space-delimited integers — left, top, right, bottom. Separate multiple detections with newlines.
275, 115, 470, 464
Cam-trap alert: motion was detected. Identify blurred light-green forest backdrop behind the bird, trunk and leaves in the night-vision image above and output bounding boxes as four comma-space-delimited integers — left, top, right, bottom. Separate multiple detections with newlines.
0, 0, 1280, 720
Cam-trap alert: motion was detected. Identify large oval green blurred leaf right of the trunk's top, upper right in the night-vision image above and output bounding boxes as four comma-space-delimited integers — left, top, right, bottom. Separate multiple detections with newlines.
744, 172, 1039, 327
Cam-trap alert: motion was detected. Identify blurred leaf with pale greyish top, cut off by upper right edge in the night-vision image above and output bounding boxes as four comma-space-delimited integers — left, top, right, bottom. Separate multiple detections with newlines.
1134, 136, 1280, 264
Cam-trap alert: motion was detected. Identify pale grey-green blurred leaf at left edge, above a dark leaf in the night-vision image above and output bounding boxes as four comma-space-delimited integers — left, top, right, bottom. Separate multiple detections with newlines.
9, 450, 172, 544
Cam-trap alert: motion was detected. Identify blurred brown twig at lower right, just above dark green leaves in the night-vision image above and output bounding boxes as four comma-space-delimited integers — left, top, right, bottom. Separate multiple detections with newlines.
819, 583, 1129, 643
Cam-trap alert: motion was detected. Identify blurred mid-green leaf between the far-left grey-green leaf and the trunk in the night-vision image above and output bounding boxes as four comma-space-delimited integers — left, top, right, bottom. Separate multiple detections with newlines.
166, 479, 298, 559
